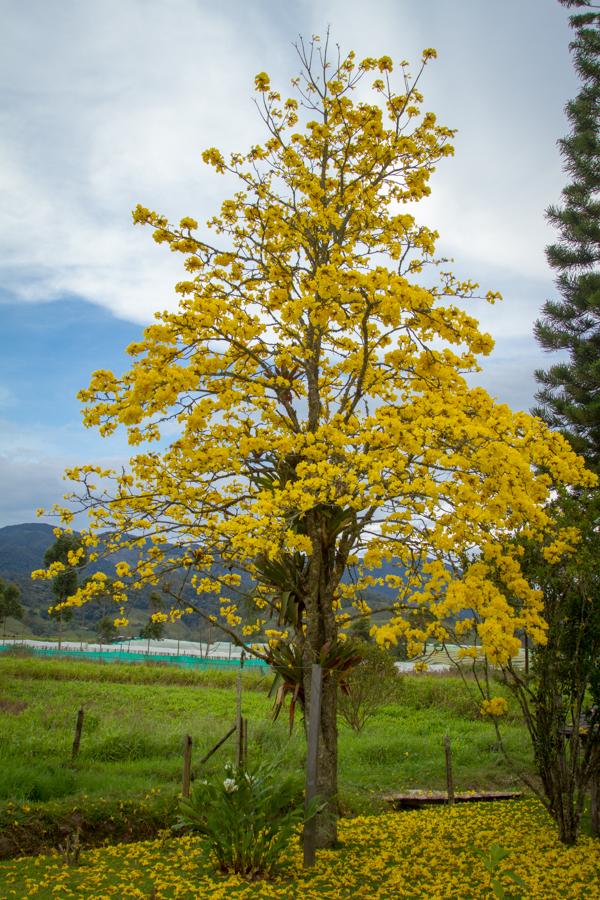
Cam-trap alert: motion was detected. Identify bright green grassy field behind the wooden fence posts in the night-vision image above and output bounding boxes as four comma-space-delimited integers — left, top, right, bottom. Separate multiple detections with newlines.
0, 656, 529, 813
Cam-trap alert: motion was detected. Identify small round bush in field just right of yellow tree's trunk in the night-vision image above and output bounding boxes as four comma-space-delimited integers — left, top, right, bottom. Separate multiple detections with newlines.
338, 642, 400, 731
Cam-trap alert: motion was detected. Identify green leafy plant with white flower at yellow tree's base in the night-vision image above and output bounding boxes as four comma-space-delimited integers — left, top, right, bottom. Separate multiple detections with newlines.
176, 762, 315, 880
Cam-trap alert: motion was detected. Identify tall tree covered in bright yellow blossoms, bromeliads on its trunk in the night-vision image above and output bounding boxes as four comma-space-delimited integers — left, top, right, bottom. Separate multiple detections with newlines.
35, 38, 586, 846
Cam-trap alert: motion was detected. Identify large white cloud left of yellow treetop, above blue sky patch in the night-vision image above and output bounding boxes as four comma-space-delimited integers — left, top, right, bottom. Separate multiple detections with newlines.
0, 0, 290, 321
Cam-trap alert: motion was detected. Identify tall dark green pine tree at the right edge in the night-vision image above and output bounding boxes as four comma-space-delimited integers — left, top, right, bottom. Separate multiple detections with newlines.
534, 0, 600, 470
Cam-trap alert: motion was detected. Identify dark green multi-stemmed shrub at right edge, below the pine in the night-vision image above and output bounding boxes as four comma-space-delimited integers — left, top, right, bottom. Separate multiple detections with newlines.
449, 488, 600, 844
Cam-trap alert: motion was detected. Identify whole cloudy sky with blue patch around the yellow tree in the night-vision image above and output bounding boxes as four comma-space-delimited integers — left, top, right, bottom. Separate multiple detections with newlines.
0, 0, 577, 526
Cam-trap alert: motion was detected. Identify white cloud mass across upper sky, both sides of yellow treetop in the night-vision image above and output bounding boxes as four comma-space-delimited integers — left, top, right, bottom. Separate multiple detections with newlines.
0, 0, 573, 321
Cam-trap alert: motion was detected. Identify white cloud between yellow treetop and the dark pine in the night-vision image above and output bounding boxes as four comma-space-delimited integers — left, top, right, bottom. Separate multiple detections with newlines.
304, 0, 577, 286
